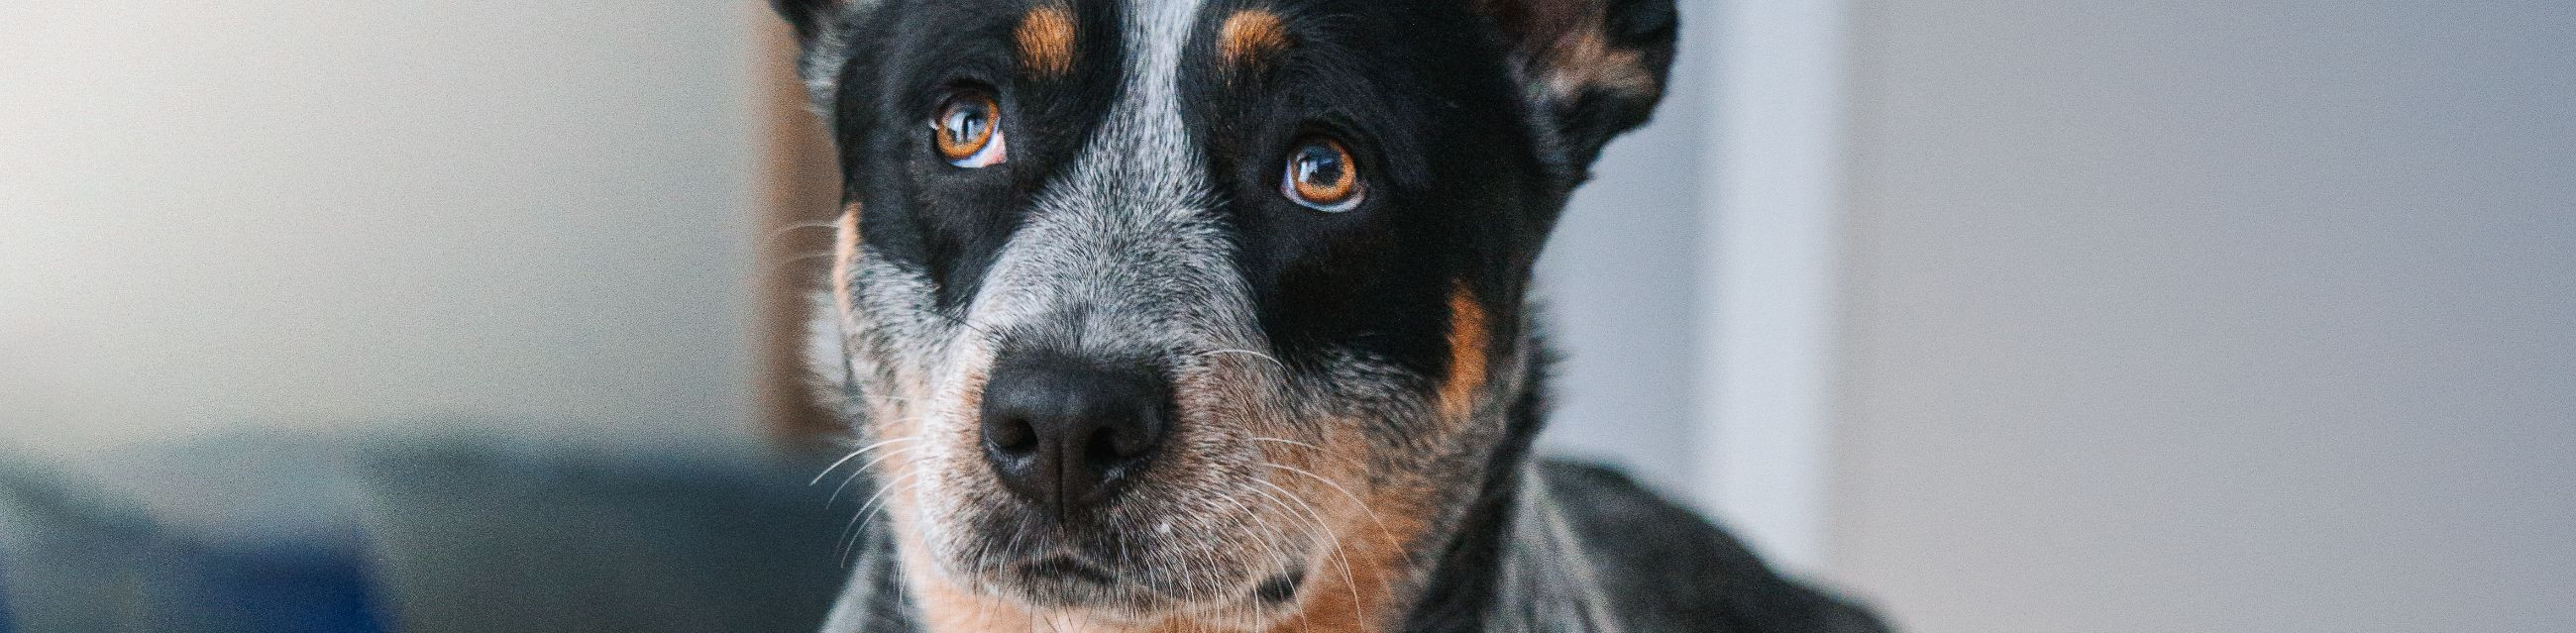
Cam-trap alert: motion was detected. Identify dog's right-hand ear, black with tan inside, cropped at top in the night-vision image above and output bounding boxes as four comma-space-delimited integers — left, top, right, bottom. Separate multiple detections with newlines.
1471, 0, 1677, 177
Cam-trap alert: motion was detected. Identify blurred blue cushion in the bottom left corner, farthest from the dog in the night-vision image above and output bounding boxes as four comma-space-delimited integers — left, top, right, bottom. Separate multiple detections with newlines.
0, 438, 383, 633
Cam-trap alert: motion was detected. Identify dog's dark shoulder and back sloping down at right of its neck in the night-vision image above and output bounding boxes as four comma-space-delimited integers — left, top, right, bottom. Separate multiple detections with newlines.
1538, 461, 1885, 633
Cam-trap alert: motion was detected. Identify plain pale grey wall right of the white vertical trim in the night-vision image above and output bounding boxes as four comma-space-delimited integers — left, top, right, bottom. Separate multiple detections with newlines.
1832, 0, 2576, 633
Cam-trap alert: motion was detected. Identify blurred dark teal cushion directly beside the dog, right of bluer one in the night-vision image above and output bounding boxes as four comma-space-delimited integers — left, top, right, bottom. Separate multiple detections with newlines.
361, 438, 844, 633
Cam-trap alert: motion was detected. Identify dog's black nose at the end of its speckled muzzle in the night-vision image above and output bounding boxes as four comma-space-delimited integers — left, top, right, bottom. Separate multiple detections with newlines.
982, 353, 1172, 517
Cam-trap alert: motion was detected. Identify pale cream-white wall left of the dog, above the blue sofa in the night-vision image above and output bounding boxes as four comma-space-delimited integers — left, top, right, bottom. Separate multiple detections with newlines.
0, 0, 757, 453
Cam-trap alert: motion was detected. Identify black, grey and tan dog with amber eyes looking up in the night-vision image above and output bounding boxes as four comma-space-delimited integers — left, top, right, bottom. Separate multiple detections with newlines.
773, 0, 1883, 633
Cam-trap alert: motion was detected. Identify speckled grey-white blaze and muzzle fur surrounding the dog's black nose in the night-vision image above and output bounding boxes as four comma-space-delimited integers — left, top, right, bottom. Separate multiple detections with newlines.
808, 0, 1324, 617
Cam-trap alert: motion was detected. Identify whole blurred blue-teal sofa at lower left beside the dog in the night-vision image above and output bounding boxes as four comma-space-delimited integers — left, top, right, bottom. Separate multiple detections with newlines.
0, 424, 850, 633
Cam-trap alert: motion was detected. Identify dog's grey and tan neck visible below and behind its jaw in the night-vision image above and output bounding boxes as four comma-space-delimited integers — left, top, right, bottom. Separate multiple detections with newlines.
824, 342, 1613, 633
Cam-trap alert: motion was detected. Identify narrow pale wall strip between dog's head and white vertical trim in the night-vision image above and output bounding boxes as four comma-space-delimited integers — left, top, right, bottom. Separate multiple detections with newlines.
1538, 3, 1718, 496
